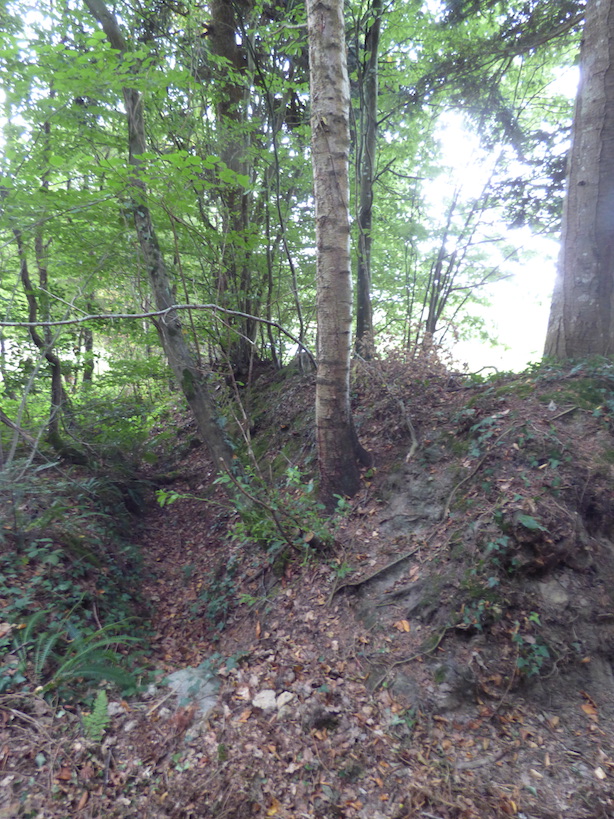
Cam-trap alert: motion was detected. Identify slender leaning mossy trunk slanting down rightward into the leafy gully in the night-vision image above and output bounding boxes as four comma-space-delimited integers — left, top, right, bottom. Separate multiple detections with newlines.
85, 0, 233, 469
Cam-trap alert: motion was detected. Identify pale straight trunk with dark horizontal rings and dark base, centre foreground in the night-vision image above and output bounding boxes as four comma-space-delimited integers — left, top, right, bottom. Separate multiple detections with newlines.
307, 0, 368, 508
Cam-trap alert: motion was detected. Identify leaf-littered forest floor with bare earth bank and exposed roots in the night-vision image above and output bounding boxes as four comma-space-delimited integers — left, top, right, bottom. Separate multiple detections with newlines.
0, 359, 614, 819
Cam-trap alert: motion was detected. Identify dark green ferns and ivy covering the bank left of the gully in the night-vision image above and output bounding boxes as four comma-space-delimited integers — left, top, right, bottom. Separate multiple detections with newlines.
0, 464, 145, 698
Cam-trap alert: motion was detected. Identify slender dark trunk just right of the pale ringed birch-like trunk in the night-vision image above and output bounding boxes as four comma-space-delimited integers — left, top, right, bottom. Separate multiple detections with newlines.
356, 0, 382, 356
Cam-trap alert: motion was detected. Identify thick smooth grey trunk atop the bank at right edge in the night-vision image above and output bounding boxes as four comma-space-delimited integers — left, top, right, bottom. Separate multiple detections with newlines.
544, 0, 614, 360
